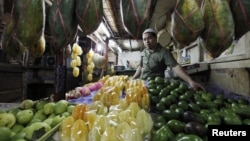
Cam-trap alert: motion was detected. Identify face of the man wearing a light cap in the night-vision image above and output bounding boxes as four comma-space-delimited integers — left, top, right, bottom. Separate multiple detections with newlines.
142, 33, 157, 49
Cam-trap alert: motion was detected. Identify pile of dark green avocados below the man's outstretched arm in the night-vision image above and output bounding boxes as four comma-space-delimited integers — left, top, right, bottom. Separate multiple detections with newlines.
147, 77, 250, 141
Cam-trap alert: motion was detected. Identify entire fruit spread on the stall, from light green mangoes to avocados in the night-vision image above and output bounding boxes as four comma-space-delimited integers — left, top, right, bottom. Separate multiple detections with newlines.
0, 75, 250, 141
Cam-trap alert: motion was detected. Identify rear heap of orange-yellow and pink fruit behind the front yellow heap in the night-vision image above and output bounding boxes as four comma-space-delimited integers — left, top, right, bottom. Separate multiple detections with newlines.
66, 75, 150, 110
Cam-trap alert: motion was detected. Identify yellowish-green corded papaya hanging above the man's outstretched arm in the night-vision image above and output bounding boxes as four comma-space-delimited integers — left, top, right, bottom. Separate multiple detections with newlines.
171, 0, 204, 47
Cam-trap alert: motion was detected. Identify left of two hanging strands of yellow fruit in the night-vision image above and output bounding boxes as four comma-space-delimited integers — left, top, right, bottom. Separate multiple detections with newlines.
71, 43, 82, 77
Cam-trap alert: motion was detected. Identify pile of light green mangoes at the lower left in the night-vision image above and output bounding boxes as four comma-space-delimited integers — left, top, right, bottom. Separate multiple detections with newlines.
0, 99, 75, 141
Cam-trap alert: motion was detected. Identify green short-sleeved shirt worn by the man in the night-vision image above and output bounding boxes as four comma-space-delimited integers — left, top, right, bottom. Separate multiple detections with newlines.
140, 44, 178, 80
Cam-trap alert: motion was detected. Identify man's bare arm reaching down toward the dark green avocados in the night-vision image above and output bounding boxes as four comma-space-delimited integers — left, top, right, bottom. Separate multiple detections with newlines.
173, 65, 206, 91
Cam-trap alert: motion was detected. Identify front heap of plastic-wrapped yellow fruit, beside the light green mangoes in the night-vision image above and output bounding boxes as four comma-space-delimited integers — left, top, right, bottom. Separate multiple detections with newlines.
59, 99, 153, 141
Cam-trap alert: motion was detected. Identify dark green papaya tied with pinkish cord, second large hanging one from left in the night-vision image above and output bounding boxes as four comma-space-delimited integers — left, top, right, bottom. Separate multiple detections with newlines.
48, 0, 77, 53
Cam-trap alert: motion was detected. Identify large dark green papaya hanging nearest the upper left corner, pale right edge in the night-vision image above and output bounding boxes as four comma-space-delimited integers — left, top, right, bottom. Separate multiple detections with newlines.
13, 0, 45, 47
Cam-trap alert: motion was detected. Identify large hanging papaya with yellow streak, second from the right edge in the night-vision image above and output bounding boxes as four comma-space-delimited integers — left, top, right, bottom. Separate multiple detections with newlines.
199, 0, 235, 58
